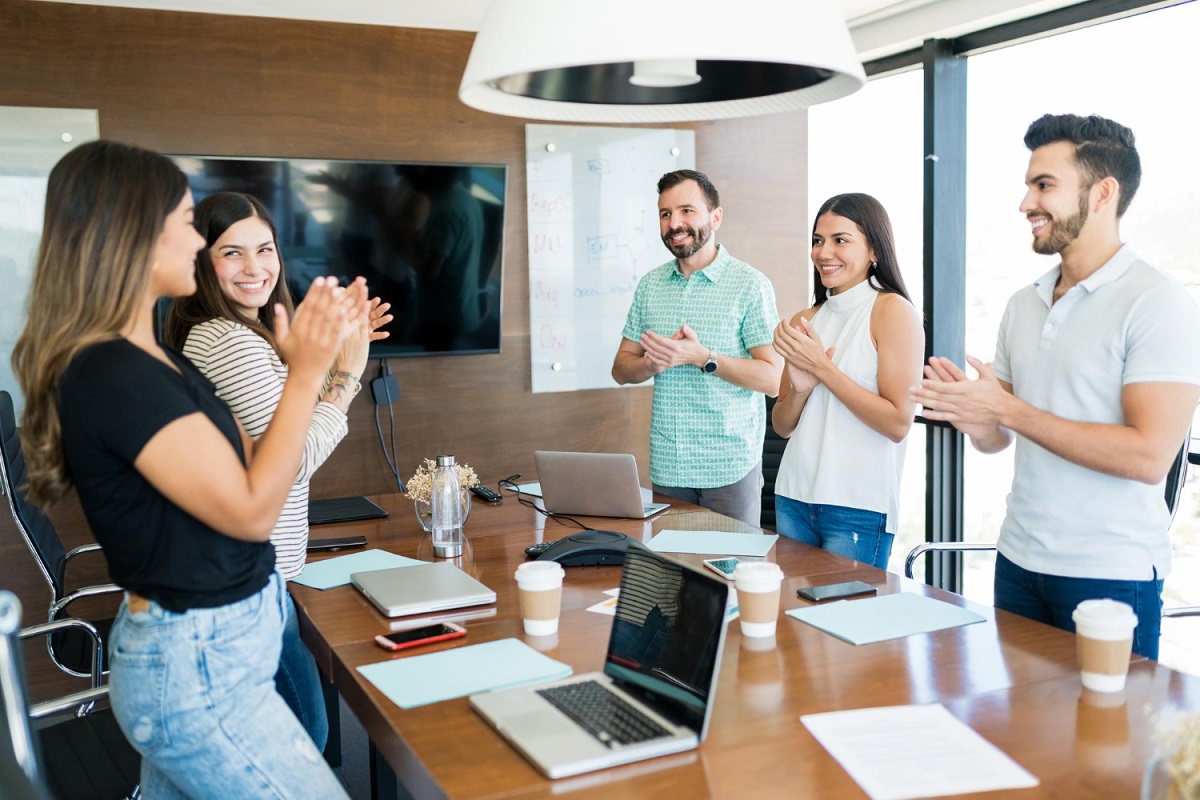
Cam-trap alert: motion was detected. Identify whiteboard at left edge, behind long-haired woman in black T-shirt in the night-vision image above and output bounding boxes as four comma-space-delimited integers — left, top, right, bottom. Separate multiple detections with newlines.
0, 106, 100, 420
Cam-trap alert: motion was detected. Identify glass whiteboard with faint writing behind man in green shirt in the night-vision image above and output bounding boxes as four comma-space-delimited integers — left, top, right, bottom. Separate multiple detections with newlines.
526, 125, 696, 392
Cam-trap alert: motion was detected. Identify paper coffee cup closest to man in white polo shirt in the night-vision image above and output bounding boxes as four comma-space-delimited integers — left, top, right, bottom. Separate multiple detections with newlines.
1070, 599, 1138, 692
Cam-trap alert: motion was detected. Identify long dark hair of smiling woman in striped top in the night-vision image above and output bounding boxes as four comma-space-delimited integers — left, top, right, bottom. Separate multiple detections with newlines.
163, 192, 295, 357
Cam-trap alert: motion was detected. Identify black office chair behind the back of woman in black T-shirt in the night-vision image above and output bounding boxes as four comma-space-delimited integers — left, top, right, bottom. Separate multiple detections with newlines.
0, 391, 121, 678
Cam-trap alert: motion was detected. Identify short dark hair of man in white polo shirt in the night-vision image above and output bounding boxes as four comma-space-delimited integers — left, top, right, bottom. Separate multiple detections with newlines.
1025, 114, 1141, 217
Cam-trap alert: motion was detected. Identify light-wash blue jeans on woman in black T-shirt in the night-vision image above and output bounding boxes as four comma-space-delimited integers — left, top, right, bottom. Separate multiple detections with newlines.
109, 575, 346, 800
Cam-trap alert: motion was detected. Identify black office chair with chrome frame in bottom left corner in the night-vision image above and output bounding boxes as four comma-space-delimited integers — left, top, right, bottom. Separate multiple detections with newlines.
0, 591, 142, 800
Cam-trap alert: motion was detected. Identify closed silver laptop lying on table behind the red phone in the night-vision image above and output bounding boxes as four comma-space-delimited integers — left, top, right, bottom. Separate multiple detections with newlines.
350, 561, 496, 616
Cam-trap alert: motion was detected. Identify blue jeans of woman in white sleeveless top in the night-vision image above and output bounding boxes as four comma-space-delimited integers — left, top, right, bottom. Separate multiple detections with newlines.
775, 494, 895, 570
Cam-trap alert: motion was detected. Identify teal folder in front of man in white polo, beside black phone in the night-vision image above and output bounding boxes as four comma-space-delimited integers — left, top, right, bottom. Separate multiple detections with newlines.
787, 591, 984, 644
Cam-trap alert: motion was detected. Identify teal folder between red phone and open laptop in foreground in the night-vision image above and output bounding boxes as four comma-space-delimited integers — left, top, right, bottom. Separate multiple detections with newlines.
359, 639, 571, 709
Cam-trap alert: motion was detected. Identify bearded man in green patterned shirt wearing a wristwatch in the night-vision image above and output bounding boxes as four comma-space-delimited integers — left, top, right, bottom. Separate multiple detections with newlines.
612, 169, 784, 527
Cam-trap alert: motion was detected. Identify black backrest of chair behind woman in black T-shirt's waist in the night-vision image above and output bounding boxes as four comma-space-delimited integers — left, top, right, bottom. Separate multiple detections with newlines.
0, 391, 67, 602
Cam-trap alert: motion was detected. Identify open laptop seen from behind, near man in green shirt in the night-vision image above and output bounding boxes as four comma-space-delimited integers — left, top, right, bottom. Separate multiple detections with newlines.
533, 450, 671, 519
